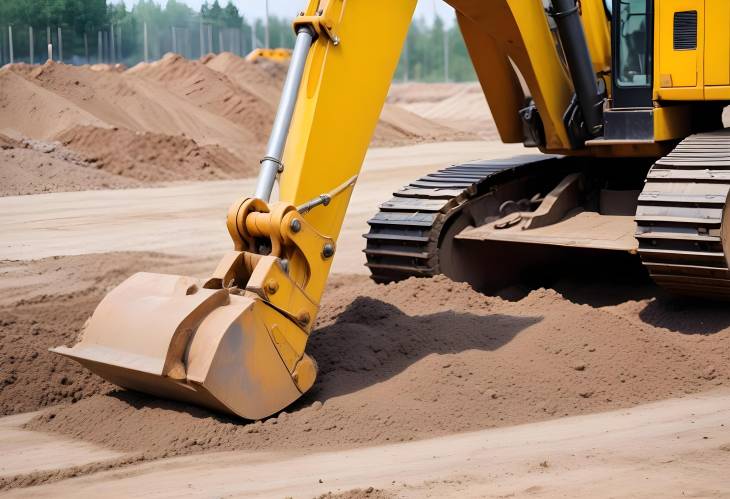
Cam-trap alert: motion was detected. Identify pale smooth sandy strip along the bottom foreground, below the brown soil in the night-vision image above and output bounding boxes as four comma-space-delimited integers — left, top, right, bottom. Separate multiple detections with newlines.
0, 391, 730, 498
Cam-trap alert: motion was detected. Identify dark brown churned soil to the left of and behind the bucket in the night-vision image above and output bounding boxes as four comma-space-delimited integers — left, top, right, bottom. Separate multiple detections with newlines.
0, 253, 212, 415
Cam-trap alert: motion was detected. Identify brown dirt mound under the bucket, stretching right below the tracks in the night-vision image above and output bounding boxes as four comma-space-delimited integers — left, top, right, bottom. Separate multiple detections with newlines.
12, 256, 730, 458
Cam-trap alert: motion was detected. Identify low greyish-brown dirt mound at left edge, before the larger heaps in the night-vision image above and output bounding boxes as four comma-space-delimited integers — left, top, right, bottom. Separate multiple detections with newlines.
0, 135, 140, 196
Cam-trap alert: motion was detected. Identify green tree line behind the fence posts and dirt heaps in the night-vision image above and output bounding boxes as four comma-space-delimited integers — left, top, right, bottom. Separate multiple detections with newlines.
0, 0, 475, 81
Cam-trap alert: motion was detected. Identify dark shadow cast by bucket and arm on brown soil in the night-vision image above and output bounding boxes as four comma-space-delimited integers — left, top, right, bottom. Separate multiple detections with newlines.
109, 297, 542, 424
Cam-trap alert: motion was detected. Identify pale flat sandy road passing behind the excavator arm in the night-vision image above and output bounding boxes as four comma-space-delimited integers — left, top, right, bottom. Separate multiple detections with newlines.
0, 142, 527, 273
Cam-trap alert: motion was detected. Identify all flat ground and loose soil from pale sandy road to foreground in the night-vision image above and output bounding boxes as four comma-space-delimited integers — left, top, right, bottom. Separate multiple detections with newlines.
0, 143, 730, 498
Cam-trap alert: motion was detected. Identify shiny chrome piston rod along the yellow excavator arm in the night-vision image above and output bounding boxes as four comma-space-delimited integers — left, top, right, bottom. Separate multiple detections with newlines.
254, 26, 313, 202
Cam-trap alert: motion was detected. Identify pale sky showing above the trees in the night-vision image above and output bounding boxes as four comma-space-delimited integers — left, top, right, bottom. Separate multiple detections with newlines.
119, 0, 454, 24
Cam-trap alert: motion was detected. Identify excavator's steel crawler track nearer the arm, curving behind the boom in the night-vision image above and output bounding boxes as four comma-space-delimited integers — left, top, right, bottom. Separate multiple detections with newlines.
364, 155, 557, 282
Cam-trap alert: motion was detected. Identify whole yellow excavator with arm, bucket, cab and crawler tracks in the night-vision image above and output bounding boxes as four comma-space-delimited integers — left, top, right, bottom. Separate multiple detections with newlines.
55, 0, 730, 419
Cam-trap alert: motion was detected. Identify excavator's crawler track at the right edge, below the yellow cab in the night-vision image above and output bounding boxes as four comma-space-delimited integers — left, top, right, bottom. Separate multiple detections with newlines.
636, 130, 730, 299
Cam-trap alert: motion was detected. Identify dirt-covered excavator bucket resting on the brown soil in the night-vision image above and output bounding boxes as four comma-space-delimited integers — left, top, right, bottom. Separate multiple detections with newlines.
53, 273, 316, 419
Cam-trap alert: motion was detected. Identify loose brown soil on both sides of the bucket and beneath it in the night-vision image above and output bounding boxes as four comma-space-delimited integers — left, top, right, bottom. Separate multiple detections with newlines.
0, 254, 730, 466
